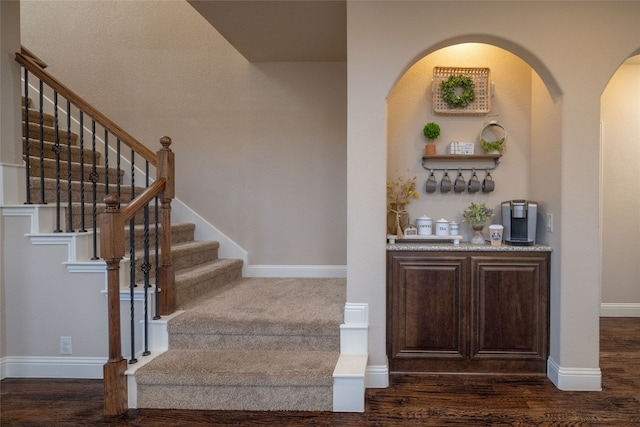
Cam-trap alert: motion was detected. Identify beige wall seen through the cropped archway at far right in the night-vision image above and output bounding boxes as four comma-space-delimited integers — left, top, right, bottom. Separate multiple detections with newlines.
601, 63, 640, 310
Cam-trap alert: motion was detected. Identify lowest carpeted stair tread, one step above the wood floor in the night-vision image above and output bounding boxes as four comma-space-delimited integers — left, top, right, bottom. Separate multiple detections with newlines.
136, 350, 339, 387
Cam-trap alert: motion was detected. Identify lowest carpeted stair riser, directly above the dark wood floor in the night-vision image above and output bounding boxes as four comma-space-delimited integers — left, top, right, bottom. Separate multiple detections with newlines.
137, 384, 333, 411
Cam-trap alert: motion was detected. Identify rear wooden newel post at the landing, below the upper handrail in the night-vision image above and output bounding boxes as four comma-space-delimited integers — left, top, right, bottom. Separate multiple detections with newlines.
157, 136, 176, 315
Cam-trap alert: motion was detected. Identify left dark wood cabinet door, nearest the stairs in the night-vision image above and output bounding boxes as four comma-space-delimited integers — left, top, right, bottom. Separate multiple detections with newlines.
387, 253, 468, 372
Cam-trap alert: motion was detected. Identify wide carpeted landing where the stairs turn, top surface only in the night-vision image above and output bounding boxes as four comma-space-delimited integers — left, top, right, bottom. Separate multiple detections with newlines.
168, 278, 346, 336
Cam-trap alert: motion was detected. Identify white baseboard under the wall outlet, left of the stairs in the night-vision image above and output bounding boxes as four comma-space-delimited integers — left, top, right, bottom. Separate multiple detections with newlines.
0, 356, 107, 379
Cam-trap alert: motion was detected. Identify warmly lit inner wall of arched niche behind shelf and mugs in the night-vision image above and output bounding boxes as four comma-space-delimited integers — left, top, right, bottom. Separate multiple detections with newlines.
387, 41, 562, 380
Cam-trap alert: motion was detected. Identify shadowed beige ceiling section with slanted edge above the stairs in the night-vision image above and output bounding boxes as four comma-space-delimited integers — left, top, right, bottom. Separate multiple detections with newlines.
189, 0, 347, 62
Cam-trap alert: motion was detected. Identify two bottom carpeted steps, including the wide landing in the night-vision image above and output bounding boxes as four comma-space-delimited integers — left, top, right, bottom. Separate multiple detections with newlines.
135, 278, 346, 411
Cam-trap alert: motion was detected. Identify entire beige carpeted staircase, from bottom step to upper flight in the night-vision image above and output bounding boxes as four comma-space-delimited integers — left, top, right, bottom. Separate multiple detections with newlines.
23, 100, 346, 411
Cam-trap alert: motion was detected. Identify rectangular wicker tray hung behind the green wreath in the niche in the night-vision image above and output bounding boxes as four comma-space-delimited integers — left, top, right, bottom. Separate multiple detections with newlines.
432, 67, 491, 114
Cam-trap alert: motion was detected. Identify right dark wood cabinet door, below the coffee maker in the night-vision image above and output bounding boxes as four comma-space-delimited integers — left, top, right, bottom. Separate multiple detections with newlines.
471, 254, 549, 372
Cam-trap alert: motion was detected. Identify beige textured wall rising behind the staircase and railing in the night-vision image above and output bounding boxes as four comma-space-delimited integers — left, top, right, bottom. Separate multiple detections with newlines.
21, 1, 346, 265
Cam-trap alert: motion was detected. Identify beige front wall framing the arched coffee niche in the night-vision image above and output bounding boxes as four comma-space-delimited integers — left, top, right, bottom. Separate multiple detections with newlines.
347, 1, 640, 389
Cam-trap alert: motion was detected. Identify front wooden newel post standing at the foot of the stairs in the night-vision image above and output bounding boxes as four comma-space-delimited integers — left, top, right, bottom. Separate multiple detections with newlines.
100, 194, 128, 416
